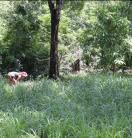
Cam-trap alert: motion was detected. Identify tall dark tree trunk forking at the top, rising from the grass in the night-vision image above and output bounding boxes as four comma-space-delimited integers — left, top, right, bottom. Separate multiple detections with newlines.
48, 0, 62, 79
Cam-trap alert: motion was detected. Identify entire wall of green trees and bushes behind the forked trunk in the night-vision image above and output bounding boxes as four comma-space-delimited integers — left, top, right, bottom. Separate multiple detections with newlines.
0, 1, 132, 76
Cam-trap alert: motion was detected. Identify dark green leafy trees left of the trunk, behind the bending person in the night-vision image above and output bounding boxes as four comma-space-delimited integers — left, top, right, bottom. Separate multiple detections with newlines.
2, 1, 49, 75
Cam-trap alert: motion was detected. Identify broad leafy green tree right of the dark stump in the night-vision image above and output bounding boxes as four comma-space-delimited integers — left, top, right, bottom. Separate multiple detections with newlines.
80, 2, 130, 69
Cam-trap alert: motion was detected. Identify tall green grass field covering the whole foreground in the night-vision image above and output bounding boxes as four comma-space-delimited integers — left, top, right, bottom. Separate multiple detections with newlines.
0, 75, 132, 138
